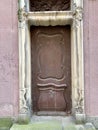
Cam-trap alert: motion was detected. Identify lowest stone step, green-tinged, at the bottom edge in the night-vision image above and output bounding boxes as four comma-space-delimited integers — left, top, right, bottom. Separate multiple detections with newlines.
10, 121, 95, 130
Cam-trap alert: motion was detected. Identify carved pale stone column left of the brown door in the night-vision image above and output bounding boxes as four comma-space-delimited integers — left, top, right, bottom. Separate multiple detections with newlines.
18, 0, 31, 115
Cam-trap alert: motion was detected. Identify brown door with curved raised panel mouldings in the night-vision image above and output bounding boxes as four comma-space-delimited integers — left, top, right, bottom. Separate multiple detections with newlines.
31, 26, 71, 115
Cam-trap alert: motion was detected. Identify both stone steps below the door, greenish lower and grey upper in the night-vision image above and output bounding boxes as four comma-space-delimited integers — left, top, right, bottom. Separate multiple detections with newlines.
10, 116, 95, 130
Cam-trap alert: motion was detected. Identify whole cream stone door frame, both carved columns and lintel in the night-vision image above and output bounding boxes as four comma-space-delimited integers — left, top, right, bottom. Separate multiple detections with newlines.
18, 0, 85, 118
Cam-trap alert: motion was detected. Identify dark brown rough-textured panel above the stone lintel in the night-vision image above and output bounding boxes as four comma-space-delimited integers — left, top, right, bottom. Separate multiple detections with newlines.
30, 0, 70, 11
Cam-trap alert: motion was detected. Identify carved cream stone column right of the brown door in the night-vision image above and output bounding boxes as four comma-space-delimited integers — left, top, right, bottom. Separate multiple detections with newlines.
72, 0, 85, 122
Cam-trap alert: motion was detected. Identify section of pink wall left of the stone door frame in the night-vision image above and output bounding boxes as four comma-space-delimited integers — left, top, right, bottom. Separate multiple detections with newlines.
0, 0, 19, 117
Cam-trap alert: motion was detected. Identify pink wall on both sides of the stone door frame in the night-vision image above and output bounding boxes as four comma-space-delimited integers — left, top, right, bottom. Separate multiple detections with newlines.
0, 0, 98, 117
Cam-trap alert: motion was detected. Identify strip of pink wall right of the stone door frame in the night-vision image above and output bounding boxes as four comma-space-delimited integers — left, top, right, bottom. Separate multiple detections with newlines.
84, 0, 98, 116
